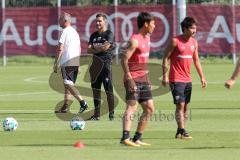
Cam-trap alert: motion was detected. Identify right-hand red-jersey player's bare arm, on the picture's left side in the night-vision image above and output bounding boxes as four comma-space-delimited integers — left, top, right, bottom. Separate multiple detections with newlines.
162, 38, 177, 86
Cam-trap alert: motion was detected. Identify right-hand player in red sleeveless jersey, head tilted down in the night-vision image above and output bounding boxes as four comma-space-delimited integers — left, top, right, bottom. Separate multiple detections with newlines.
162, 17, 207, 139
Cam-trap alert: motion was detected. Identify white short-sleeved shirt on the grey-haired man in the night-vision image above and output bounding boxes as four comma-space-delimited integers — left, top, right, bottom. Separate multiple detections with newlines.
59, 26, 81, 66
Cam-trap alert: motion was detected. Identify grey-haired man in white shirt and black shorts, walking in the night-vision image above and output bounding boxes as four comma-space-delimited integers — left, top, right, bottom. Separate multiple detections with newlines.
53, 12, 88, 113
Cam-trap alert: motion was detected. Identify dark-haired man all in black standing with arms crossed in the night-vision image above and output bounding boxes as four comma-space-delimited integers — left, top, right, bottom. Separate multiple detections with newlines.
79, 13, 115, 120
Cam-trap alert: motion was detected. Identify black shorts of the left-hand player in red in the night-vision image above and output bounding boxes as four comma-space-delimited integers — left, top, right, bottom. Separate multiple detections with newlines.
124, 82, 152, 103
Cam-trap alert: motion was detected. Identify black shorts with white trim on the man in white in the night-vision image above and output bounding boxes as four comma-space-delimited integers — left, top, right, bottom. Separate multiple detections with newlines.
61, 66, 79, 85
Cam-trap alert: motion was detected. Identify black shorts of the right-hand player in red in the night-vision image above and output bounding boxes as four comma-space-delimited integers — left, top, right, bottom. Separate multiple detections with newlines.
170, 82, 192, 104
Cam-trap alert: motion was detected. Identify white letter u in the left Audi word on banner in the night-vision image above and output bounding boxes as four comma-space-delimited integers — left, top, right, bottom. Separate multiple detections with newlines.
24, 26, 43, 46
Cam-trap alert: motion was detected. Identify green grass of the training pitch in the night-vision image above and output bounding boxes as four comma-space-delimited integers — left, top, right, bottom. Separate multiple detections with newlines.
0, 58, 240, 160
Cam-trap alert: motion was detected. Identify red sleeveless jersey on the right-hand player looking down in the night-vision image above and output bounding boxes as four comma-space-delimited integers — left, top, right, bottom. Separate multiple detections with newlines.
169, 35, 197, 82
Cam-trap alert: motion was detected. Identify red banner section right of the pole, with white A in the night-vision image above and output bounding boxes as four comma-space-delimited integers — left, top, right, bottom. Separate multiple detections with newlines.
187, 5, 240, 55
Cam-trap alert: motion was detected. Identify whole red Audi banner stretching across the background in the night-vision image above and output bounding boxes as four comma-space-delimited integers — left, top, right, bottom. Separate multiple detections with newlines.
0, 5, 240, 55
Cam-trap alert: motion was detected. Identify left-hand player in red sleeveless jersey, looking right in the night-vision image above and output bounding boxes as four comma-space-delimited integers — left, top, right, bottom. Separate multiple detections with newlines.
121, 12, 155, 147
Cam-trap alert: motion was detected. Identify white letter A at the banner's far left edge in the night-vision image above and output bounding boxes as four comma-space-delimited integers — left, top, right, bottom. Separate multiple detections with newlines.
0, 19, 23, 46
